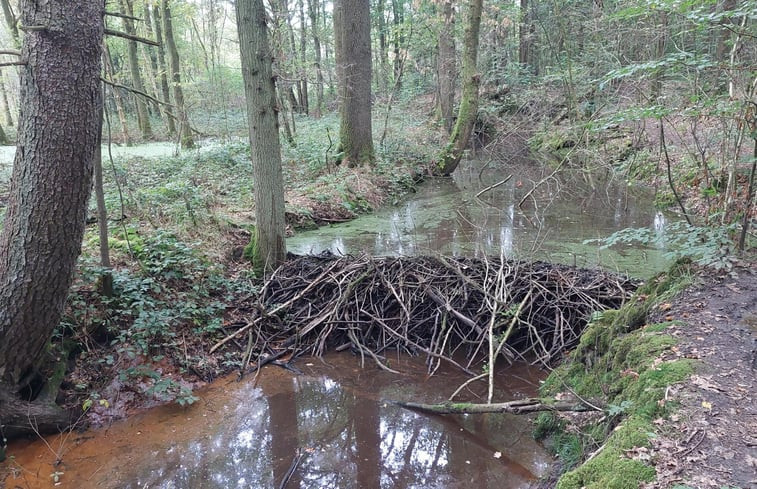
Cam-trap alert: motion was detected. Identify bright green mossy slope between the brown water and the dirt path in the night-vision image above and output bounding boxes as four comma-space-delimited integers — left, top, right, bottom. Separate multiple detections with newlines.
535, 263, 693, 489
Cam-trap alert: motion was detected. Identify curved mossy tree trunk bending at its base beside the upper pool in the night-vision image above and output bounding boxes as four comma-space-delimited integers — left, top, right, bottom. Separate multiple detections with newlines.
434, 0, 484, 175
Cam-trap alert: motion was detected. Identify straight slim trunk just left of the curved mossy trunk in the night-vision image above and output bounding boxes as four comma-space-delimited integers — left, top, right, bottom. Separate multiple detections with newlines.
437, 0, 457, 134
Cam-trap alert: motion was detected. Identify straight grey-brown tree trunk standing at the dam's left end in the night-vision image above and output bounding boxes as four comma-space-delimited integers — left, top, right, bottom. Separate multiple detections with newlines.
236, 0, 286, 271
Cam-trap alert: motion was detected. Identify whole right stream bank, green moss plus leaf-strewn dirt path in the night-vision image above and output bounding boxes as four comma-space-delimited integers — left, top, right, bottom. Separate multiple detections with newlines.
536, 263, 757, 489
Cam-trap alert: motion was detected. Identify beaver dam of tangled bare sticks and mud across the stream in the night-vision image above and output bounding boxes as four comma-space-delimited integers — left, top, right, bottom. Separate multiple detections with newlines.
211, 253, 638, 374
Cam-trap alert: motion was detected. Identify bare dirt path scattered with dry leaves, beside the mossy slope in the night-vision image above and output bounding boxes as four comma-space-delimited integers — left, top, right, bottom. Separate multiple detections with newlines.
644, 262, 757, 489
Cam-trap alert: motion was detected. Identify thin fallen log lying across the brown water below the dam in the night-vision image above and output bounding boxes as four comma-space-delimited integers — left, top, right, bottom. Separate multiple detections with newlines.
387, 397, 599, 414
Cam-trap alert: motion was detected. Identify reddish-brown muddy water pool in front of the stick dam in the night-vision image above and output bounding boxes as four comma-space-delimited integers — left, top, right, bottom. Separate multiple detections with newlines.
0, 354, 553, 489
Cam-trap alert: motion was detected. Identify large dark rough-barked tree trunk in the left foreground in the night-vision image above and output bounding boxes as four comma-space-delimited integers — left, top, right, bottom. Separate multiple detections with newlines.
0, 0, 104, 435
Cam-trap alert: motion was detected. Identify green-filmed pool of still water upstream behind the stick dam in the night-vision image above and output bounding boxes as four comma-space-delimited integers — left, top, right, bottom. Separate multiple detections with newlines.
287, 160, 669, 278
